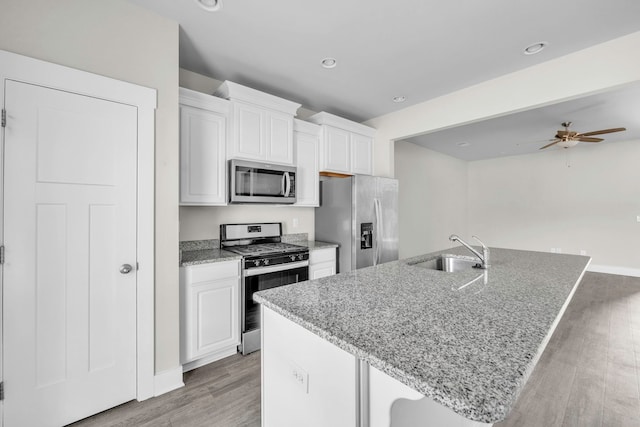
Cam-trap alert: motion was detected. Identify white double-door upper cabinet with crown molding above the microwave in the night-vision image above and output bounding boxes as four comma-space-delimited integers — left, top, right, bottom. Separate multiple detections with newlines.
214, 81, 300, 165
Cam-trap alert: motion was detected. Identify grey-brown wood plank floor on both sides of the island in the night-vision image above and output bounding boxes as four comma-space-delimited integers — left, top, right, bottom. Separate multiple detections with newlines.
73, 273, 640, 427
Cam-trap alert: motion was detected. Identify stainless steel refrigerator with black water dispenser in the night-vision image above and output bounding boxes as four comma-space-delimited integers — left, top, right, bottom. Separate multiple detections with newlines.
315, 175, 398, 273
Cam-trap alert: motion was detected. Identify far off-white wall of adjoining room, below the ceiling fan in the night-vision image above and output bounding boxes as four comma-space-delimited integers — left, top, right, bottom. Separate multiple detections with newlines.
468, 141, 640, 269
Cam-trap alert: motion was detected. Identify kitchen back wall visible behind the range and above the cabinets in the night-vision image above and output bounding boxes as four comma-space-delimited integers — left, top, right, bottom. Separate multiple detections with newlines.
180, 69, 315, 241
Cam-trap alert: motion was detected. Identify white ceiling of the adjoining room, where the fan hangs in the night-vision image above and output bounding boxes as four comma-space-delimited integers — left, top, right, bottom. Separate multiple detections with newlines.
405, 84, 640, 161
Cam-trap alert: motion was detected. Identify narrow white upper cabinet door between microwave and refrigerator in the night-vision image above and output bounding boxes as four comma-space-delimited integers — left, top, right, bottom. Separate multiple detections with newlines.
294, 132, 320, 206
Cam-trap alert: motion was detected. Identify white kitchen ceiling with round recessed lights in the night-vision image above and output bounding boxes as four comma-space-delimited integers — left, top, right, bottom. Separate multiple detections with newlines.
129, 0, 640, 123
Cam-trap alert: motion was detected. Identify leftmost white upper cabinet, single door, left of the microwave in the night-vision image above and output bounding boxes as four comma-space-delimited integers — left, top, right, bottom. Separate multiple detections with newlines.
180, 88, 229, 206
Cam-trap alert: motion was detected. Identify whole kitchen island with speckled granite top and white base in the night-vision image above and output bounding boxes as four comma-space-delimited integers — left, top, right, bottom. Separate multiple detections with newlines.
254, 248, 590, 427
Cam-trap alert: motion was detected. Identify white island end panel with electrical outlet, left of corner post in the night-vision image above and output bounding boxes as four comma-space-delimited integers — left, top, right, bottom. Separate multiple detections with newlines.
260, 306, 358, 427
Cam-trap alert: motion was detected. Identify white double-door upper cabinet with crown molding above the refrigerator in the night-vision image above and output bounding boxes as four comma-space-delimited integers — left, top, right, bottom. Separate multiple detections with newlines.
308, 112, 376, 175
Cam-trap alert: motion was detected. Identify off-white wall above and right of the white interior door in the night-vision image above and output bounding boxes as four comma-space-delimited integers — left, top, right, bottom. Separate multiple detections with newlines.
0, 0, 180, 372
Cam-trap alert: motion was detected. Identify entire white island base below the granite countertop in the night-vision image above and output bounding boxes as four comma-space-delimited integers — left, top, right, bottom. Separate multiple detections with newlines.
261, 306, 492, 427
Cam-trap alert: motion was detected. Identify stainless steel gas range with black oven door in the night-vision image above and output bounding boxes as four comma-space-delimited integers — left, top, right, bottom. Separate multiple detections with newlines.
220, 222, 309, 354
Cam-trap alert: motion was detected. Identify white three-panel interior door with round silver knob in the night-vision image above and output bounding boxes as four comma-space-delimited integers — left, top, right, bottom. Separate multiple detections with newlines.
3, 80, 137, 427
